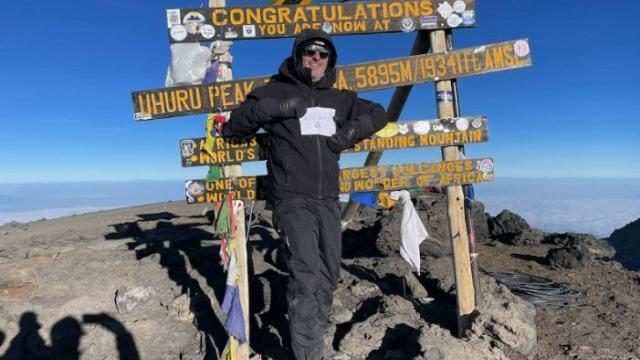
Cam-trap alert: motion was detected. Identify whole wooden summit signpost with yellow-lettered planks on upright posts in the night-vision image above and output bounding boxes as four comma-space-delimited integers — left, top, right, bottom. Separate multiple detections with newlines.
131, 0, 531, 359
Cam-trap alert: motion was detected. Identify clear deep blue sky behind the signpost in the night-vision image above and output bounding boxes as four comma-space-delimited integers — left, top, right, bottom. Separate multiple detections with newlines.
0, 0, 640, 183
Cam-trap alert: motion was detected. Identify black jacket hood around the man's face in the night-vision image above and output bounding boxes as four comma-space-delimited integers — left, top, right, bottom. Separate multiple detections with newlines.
279, 29, 338, 88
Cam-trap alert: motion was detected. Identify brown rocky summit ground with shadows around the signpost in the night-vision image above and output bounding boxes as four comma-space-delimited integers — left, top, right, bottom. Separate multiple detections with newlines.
0, 193, 640, 359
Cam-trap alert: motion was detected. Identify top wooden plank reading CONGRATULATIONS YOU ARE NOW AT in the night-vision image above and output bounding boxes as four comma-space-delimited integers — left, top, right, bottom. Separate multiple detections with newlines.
167, 0, 476, 43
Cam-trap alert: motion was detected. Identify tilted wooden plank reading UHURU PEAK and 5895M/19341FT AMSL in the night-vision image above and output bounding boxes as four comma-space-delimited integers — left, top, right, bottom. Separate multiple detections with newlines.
131, 39, 531, 120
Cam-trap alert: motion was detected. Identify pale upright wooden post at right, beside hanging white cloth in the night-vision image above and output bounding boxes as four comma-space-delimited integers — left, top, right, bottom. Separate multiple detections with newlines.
430, 30, 475, 337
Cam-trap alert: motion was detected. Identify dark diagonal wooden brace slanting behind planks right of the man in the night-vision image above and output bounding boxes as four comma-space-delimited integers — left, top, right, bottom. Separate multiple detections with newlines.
342, 31, 430, 229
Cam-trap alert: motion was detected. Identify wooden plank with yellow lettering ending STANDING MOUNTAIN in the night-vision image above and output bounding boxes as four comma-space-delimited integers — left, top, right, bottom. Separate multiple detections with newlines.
180, 116, 489, 167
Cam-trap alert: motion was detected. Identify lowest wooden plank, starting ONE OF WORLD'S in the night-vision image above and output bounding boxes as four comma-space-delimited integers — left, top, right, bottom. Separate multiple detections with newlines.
185, 158, 494, 204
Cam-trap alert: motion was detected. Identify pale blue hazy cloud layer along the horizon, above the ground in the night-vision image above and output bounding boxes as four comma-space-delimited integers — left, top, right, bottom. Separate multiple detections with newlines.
0, 178, 640, 238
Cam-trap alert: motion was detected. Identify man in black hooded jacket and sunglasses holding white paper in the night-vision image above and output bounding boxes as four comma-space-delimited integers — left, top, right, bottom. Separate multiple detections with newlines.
222, 30, 387, 359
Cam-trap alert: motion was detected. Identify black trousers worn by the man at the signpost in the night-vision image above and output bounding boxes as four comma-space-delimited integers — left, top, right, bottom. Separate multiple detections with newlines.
273, 198, 342, 360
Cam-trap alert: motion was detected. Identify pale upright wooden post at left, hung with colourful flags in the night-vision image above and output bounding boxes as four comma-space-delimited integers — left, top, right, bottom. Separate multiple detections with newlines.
209, 0, 251, 360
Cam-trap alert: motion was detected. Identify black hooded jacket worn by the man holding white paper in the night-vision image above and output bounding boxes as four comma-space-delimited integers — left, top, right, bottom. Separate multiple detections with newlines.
222, 30, 387, 199
